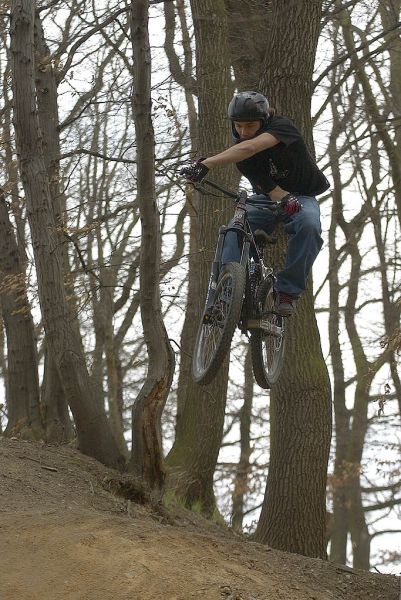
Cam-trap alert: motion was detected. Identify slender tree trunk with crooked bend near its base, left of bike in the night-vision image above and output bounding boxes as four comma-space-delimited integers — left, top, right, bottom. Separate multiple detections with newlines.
131, 0, 175, 491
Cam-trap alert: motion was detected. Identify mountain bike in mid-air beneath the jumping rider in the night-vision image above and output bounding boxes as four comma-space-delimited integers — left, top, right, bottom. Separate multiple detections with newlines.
192, 179, 286, 389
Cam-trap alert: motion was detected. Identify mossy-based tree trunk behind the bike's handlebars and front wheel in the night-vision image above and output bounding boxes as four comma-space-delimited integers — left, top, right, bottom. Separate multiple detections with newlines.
167, 0, 235, 515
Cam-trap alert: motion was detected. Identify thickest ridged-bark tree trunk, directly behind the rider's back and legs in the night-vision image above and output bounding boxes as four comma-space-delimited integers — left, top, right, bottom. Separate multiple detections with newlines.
255, 0, 331, 558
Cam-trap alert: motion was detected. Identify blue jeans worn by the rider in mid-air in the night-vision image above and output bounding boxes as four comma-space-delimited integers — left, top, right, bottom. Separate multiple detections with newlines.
222, 195, 323, 297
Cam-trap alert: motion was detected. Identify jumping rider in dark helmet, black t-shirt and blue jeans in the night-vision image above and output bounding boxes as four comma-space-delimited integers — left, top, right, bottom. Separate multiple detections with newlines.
182, 91, 329, 316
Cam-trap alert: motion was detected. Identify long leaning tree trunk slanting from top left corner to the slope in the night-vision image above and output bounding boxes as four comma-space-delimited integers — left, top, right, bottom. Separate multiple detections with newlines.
10, 0, 124, 467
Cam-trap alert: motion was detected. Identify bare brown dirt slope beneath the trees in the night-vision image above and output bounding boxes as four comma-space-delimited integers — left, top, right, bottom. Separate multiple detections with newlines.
0, 438, 400, 600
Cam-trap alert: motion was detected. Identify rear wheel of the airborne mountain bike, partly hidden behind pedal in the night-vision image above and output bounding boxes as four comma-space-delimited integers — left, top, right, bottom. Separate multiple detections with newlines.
250, 277, 286, 390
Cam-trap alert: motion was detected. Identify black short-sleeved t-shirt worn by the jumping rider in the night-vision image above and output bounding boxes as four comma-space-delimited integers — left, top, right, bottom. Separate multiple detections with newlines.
237, 116, 330, 196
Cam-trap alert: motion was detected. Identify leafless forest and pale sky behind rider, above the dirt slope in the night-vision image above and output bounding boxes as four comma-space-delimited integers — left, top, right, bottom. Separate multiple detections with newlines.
0, 0, 401, 572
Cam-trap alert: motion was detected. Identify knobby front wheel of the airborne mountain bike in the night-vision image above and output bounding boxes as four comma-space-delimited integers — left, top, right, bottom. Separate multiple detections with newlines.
192, 263, 245, 385
